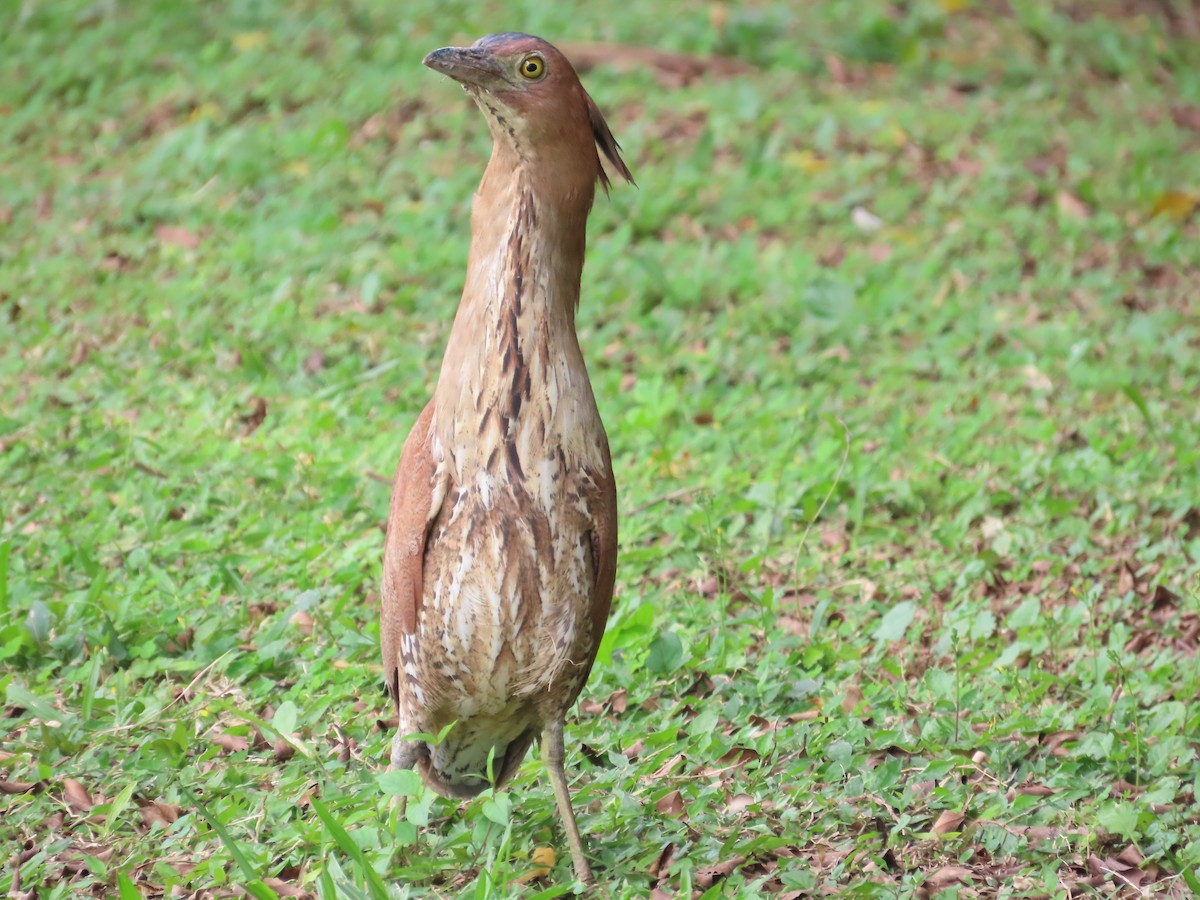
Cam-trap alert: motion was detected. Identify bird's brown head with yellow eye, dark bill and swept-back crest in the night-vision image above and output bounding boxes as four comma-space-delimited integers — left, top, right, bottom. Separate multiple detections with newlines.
425, 34, 634, 190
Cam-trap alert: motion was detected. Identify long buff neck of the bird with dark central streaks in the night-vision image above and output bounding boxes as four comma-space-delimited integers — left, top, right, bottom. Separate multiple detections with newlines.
433, 152, 596, 478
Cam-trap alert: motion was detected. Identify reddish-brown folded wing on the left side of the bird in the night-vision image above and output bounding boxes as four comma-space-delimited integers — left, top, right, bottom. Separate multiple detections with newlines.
379, 400, 445, 700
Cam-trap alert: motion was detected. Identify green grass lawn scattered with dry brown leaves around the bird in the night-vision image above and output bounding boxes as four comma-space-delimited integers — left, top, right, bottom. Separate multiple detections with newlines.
0, 0, 1200, 900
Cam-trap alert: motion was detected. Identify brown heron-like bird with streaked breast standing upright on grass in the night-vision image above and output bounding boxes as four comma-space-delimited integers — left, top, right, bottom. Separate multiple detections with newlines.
380, 32, 635, 884
